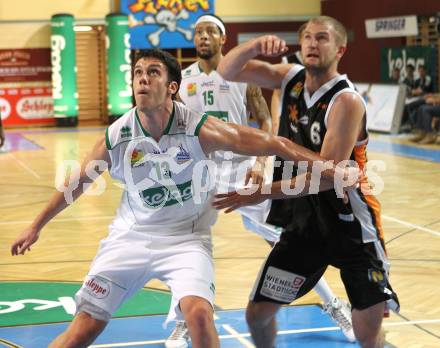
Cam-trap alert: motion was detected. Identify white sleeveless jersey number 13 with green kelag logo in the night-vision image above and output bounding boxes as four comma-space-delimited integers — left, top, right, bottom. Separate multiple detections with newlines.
106, 102, 215, 233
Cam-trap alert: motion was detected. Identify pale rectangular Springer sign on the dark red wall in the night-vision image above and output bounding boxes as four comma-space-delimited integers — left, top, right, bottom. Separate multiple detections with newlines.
365, 16, 419, 39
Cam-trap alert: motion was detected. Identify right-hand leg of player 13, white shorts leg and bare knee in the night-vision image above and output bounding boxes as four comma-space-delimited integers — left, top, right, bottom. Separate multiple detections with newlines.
154, 226, 219, 347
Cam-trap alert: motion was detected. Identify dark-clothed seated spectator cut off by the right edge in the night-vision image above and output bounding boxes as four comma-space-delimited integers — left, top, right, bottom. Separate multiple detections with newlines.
410, 94, 440, 145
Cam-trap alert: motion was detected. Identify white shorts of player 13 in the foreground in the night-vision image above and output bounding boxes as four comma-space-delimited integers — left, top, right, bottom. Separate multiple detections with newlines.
75, 227, 215, 323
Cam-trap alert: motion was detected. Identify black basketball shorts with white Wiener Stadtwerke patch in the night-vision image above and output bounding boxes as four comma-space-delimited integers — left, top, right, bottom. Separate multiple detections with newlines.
250, 215, 399, 311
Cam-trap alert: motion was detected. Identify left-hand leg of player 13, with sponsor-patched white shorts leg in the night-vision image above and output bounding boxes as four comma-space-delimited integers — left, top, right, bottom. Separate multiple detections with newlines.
50, 234, 153, 348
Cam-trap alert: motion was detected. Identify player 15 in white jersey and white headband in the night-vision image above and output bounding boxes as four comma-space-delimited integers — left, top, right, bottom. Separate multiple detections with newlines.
165, 15, 355, 348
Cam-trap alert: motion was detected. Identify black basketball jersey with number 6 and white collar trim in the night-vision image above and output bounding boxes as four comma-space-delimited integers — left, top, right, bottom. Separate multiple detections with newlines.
267, 65, 377, 239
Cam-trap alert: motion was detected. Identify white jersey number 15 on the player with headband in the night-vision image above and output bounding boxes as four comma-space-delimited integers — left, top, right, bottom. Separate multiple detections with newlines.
179, 62, 255, 192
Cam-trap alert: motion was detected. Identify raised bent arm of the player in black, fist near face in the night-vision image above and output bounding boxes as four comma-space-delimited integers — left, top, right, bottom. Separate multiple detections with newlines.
217, 35, 292, 89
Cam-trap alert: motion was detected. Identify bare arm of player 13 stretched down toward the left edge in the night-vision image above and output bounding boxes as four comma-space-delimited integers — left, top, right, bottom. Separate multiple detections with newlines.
11, 137, 110, 255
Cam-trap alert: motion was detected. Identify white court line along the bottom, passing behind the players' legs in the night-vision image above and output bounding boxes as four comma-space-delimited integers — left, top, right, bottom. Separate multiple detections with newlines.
89, 319, 440, 348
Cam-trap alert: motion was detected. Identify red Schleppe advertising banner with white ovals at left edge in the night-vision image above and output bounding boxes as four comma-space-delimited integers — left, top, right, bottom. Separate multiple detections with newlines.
0, 86, 55, 126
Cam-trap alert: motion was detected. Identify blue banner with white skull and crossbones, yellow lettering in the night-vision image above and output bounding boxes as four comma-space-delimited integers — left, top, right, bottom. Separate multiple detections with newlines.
121, 0, 214, 49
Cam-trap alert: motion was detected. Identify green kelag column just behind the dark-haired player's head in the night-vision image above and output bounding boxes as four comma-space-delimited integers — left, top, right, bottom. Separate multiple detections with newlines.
105, 13, 133, 123
